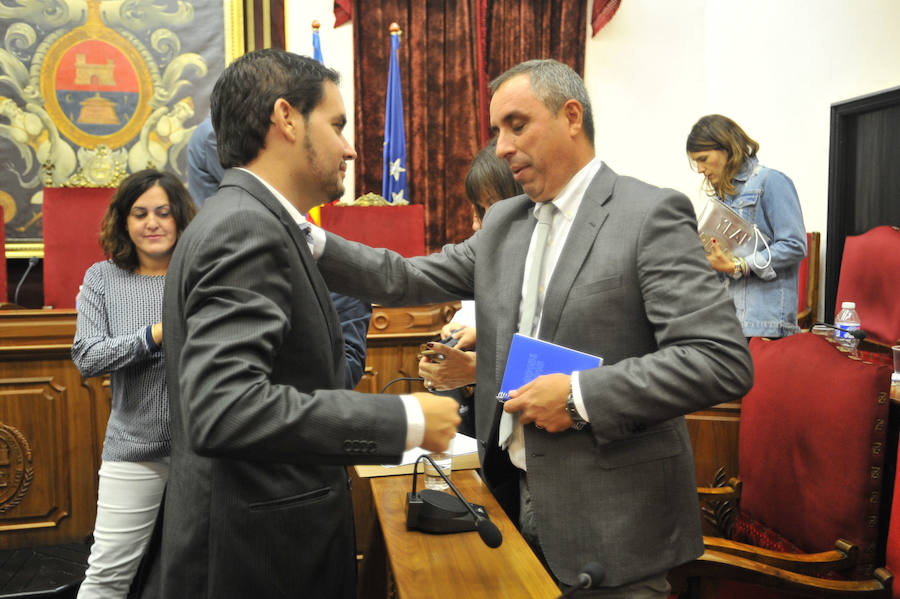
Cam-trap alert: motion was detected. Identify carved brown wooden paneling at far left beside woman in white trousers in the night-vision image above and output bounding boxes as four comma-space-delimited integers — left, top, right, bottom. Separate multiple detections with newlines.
0, 310, 109, 549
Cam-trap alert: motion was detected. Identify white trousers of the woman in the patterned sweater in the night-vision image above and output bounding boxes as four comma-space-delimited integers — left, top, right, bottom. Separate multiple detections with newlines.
78, 458, 169, 599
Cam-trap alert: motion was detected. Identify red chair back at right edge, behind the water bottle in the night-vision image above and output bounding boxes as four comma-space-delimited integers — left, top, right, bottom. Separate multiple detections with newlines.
835, 226, 900, 346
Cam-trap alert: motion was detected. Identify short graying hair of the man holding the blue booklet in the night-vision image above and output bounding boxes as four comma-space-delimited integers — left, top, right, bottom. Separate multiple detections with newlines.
491, 58, 594, 146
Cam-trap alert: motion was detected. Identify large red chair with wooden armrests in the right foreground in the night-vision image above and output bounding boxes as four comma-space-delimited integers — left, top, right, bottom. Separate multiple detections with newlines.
673, 333, 891, 599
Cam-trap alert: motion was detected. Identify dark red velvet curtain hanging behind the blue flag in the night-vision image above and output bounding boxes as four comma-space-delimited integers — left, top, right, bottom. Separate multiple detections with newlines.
352, 0, 587, 251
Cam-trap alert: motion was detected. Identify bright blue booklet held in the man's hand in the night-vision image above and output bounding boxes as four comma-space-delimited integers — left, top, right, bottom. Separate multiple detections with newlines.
497, 333, 603, 401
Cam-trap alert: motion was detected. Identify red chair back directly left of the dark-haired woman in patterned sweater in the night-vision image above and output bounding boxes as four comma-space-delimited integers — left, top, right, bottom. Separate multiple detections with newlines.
43, 187, 115, 308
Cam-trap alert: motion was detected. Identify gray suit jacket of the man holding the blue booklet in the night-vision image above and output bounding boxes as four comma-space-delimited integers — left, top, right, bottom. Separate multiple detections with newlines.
319, 165, 752, 586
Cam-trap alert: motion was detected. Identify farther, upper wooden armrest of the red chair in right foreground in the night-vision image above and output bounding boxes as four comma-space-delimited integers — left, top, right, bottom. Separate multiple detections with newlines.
703, 536, 859, 576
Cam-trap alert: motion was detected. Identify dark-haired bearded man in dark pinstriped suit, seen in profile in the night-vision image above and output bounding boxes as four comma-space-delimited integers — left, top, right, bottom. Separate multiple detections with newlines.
144, 50, 459, 599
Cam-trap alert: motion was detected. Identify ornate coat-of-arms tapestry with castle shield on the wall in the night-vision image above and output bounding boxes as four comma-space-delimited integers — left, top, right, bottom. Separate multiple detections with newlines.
0, 0, 225, 242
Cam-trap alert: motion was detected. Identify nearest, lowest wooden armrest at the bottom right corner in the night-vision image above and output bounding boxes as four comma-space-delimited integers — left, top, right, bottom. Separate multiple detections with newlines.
676, 550, 893, 599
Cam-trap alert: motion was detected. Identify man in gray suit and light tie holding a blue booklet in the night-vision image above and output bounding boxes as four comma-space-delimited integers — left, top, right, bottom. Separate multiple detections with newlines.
314, 60, 752, 597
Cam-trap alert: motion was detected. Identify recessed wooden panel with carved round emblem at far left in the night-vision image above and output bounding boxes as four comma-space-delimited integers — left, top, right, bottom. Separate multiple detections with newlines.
0, 377, 71, 531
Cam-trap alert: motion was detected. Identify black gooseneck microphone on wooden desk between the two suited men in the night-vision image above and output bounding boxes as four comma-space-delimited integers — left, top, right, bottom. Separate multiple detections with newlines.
406, 454, 503, 549
